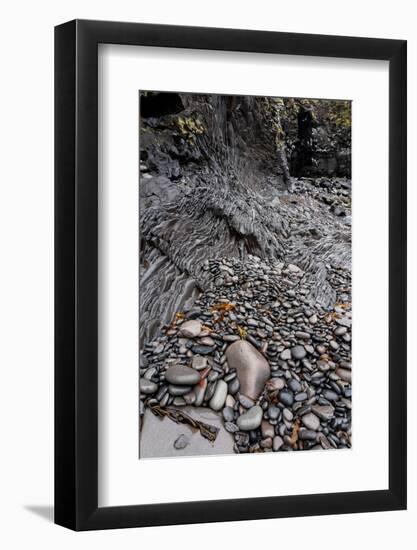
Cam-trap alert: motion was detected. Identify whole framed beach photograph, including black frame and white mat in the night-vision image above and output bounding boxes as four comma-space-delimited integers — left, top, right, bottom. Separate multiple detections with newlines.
55, 20, 407, 530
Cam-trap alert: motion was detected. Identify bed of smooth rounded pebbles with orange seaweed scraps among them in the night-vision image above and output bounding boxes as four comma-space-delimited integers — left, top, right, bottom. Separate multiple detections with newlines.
140, 256, 351, 453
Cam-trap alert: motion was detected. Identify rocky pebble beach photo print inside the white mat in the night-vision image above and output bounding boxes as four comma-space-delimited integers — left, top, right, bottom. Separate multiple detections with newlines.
138, 91, 352, 459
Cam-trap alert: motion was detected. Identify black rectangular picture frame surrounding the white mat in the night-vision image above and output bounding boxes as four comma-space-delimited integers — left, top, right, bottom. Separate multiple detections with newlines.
55, 20, 407, 530
